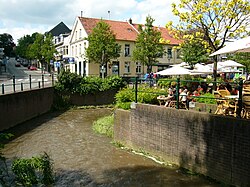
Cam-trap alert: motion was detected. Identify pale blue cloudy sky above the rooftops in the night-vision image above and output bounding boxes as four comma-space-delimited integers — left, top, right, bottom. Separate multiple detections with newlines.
0, 0, 178, 44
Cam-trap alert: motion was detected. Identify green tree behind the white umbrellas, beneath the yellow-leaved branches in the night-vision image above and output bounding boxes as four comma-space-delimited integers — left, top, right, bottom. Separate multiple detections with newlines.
181, 35, 209, 68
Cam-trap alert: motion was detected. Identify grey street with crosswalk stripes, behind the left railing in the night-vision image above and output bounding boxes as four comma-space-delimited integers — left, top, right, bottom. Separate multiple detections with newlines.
0, 58, 55, 95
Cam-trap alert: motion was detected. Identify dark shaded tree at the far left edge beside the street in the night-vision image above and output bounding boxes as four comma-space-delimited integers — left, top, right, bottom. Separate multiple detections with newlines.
0, 33, 15, 56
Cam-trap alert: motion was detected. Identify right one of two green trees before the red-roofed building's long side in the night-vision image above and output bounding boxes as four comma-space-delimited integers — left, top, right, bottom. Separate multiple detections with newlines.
133, 16, 165, 73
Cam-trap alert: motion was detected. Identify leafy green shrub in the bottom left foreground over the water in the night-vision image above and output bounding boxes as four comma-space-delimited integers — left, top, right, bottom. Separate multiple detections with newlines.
12, 153, 54, 186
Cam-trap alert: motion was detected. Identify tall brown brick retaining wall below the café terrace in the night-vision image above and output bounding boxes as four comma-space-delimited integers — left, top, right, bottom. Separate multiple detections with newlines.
114, 104, 250, 186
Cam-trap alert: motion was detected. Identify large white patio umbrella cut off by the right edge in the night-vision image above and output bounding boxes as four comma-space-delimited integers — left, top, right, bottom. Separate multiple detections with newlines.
209, 36, 250, 56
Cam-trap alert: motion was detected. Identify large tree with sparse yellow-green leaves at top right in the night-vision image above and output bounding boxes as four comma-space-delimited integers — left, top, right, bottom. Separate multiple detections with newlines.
167, 0, 250, 80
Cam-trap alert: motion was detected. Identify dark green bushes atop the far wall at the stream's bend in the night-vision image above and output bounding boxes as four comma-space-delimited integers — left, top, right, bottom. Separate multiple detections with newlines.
55, 70, 126, 95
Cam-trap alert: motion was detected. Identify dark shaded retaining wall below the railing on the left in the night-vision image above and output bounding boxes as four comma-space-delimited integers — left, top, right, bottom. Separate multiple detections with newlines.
0, 87, 54, 131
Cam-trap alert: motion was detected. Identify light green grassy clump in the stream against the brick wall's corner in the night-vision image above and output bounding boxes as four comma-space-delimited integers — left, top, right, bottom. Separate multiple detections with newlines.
92, 114, 114, 138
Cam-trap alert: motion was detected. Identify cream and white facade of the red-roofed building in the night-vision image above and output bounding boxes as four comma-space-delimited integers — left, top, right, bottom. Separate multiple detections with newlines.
56, 17, 181, 77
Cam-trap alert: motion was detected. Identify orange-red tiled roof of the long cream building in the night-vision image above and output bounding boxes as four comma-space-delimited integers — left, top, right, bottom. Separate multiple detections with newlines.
79, 17, 180, 45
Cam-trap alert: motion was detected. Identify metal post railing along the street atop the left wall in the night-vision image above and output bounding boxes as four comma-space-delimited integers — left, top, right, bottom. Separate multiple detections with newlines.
0, 74, 55, 95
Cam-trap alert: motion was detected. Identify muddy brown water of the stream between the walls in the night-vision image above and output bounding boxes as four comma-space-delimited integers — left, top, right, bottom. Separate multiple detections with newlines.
3, 109, 221, 187
